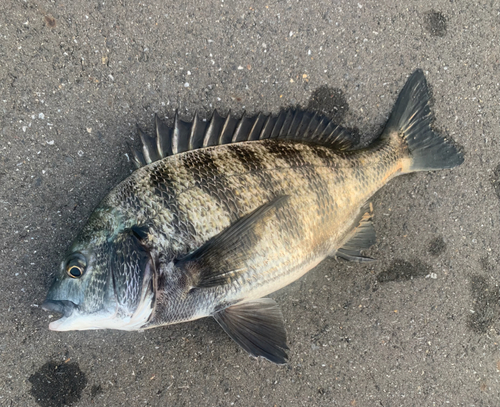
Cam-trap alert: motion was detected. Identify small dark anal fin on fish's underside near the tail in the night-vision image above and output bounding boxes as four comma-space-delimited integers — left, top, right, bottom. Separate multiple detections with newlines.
334, 204, 376, 262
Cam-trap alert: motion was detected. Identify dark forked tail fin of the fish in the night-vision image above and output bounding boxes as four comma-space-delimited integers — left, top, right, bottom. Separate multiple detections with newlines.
382, 69, 464, 172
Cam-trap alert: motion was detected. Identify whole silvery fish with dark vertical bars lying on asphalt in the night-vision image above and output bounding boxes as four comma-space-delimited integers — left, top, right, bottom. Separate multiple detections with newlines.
42, 70, 463, 364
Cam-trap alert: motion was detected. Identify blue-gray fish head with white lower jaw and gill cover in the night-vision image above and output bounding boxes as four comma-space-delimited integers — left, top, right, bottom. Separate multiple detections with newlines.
42, 207, 154, 331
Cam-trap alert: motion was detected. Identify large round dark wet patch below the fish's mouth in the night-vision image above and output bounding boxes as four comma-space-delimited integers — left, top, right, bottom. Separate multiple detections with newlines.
29, 361, 87, 407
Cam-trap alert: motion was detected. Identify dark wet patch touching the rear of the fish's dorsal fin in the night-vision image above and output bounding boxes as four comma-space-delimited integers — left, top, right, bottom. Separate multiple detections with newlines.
307, 86, 349, 124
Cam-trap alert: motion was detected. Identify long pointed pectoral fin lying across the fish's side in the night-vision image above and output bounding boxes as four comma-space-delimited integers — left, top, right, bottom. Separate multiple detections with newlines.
175, 195, 288, 288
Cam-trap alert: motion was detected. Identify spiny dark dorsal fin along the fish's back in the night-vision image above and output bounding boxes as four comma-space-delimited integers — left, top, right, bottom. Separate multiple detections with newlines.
132, 109, 356, 168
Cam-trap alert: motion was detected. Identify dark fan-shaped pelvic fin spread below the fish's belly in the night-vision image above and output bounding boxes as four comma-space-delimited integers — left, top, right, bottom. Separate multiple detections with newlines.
213, 298, 288, 364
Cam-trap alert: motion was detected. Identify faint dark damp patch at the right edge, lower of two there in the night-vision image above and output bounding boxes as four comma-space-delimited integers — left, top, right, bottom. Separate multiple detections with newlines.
467, 274, 500, 334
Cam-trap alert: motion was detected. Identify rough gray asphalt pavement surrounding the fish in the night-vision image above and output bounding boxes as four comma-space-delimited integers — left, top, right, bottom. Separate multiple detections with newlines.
0, 0, 500, 407
